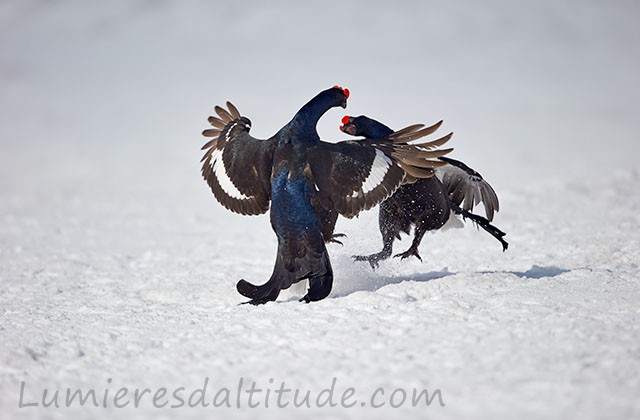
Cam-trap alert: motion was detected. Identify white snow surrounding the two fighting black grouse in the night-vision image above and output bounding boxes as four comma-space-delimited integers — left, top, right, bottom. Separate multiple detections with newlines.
0, 0, 640, 420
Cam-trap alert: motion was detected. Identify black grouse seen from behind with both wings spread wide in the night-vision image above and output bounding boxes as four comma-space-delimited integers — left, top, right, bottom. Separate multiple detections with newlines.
202, 86, 452, 304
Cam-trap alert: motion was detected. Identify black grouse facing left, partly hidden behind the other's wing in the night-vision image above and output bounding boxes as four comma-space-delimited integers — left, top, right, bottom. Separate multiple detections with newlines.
340, 115, 509, 268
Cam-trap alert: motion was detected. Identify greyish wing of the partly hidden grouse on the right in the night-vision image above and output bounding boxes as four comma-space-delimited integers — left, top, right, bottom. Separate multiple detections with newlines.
437, 157, 500, 221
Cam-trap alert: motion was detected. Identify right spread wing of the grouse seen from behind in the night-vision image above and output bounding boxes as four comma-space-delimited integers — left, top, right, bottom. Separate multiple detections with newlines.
309, 124, 453, 217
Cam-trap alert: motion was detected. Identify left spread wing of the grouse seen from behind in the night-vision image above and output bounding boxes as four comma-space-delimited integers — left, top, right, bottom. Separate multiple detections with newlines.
201, 102, 275, 215
